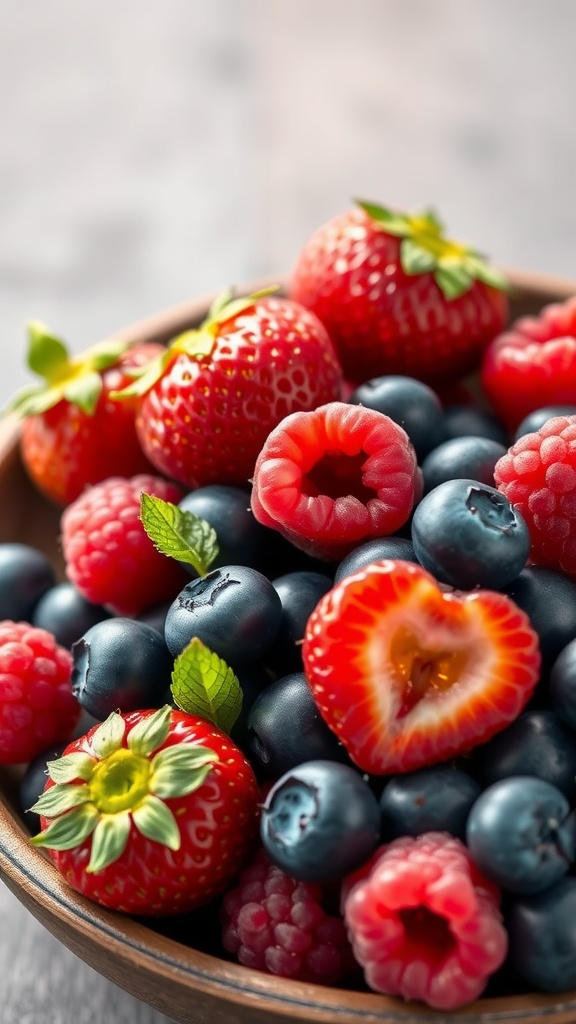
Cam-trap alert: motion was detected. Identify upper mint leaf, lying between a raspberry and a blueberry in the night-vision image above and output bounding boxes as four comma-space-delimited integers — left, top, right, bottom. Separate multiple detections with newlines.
140, 493, 218, 577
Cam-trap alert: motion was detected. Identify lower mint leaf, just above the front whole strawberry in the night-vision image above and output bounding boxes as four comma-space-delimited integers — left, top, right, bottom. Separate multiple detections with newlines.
170, 637, 242, 733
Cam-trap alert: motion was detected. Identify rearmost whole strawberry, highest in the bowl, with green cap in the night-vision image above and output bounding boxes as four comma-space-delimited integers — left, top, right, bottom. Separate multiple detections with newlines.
288, 202, 508, 385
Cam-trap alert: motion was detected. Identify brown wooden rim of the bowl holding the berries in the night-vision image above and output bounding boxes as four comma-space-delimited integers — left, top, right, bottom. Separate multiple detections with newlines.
0, 269, 576, 1024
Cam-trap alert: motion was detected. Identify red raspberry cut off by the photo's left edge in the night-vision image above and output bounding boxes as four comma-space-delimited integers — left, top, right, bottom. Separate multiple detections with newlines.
0, 620, 80, 765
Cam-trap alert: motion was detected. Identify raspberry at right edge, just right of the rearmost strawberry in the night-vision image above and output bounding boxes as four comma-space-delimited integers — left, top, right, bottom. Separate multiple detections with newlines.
482, 296, 576, 430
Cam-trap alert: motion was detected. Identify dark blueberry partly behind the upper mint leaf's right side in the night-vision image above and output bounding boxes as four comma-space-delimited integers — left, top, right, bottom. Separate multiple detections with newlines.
179, 483, 269, 572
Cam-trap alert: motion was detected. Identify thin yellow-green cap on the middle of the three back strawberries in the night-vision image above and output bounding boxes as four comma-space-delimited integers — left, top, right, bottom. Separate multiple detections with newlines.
111, 285, 279, 398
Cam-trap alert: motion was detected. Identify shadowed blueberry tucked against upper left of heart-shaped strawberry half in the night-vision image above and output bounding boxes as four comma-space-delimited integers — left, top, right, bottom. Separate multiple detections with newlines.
268, 572, 332, 676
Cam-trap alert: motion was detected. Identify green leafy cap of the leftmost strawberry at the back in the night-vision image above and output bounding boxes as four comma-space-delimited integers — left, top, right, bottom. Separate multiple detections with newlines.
5, 321, 128, 416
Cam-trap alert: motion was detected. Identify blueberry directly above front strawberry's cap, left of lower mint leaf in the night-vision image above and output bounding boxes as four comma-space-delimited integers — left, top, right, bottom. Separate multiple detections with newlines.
72, 616, 173, 721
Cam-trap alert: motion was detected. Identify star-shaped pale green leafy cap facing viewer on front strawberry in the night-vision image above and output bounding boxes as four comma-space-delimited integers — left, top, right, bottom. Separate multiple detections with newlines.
31, 705, 218, 872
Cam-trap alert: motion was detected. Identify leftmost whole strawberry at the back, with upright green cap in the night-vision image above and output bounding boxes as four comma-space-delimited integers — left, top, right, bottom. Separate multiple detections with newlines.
9, 323, 162, 505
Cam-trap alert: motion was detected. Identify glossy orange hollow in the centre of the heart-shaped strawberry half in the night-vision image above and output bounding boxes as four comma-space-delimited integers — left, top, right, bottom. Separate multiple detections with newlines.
389, 626, 469, 717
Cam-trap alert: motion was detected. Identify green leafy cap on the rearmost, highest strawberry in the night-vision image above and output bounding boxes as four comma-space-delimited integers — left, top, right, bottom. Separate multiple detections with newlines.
357, 200, 508, 300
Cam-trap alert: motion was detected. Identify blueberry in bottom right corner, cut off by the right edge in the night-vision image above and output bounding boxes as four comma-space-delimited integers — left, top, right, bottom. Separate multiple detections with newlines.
506, 878, 576, 987
